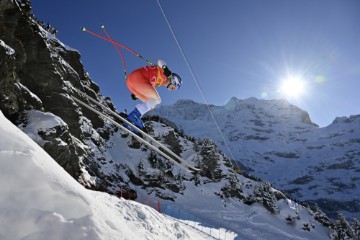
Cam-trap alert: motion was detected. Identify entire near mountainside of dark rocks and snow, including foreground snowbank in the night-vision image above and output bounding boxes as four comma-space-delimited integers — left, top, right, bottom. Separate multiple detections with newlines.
0, 0, 357, 239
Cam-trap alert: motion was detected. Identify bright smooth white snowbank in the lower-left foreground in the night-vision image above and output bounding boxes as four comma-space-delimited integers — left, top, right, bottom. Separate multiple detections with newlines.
0, 112, 214, 240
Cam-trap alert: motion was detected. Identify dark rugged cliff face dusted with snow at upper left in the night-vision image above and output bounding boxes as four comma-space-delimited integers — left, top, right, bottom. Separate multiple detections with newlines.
0, 0, 112, 184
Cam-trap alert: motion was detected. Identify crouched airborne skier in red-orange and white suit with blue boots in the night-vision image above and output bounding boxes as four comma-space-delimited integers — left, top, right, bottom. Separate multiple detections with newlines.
126, 60, 182, 130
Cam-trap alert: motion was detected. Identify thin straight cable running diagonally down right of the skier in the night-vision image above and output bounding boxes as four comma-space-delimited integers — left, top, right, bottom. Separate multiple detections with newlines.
156, 0, 239, 167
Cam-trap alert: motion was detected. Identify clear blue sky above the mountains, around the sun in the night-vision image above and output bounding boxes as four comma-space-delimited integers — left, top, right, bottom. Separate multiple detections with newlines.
31, 0, 360, 127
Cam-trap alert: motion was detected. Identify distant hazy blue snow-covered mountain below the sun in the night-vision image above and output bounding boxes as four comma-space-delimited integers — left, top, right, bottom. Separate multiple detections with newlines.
150, 98, 360, 217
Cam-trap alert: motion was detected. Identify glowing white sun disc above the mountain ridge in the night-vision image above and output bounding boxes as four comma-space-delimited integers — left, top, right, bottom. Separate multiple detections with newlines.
279, 75, 305, 98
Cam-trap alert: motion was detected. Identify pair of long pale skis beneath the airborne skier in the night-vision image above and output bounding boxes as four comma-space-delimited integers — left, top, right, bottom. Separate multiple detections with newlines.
71, 89, 200, 173
